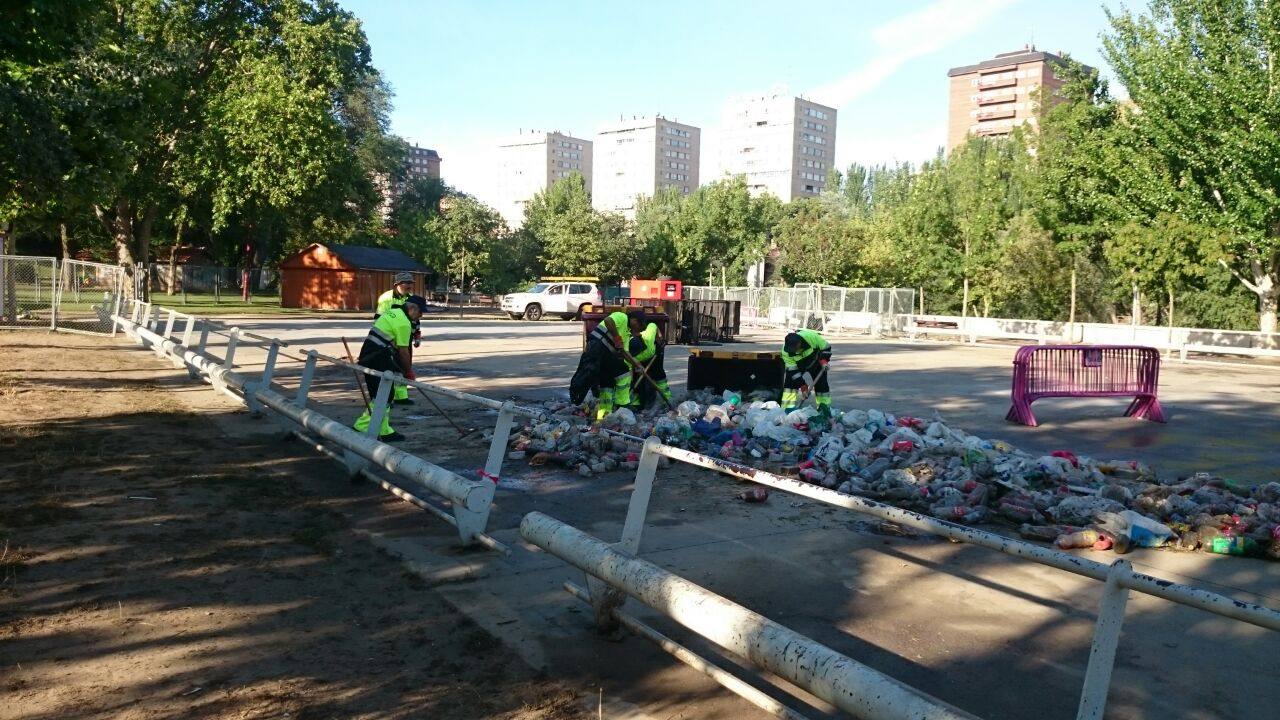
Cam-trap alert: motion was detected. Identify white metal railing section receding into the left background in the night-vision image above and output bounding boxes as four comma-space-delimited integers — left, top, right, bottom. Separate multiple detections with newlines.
114, 300, 541, 552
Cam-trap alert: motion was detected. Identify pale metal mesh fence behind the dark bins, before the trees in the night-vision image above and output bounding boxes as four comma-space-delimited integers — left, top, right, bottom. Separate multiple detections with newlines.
685, 284, 915, 334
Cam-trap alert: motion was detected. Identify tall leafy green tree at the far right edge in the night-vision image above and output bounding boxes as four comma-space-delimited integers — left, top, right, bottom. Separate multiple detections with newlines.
1103, 0, 1280, 337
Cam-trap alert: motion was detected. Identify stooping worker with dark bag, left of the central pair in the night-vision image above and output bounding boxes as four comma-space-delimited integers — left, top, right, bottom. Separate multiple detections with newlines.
570, 307, 644, 420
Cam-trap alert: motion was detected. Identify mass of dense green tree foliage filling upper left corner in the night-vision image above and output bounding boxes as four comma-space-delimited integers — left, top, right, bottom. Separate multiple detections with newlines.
0, 0, 403, 292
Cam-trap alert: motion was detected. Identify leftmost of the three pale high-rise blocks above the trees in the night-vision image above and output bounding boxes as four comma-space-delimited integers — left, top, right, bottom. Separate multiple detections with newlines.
494, 132, 591, 228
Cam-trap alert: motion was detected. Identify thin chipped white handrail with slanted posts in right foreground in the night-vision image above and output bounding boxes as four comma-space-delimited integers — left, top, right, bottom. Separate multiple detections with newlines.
591, 430, 1280, 720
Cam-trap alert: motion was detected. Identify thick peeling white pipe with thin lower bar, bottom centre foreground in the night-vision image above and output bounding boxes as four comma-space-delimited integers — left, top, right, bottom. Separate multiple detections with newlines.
520, 507, 974, 720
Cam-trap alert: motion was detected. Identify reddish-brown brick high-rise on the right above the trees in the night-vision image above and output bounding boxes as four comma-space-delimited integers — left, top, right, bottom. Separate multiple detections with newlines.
947, 45, 1085, 152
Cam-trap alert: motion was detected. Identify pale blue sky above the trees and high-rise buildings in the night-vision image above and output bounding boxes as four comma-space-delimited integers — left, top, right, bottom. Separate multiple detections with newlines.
340, 0, 1117, 197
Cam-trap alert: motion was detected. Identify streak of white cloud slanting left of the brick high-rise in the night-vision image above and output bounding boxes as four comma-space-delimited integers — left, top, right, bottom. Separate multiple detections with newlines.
809, 0, 1020, 110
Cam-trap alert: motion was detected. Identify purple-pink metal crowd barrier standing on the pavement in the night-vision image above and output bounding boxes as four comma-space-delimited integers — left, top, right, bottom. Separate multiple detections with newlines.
1005, 345, 1165, 427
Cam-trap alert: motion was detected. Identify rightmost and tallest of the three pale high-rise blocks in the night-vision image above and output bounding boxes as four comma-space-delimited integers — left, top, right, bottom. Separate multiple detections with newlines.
719, 95, 836, 202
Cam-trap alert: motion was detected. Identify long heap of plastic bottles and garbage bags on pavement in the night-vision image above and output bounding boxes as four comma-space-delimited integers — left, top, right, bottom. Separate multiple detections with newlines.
509, 391, 1280, 560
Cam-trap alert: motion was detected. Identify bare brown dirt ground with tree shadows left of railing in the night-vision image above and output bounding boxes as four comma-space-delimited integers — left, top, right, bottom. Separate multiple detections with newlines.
0, 332, 586, 720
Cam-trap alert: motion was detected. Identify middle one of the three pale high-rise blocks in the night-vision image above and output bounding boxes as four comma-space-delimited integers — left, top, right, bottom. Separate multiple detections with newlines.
591, 115, 701, 218
